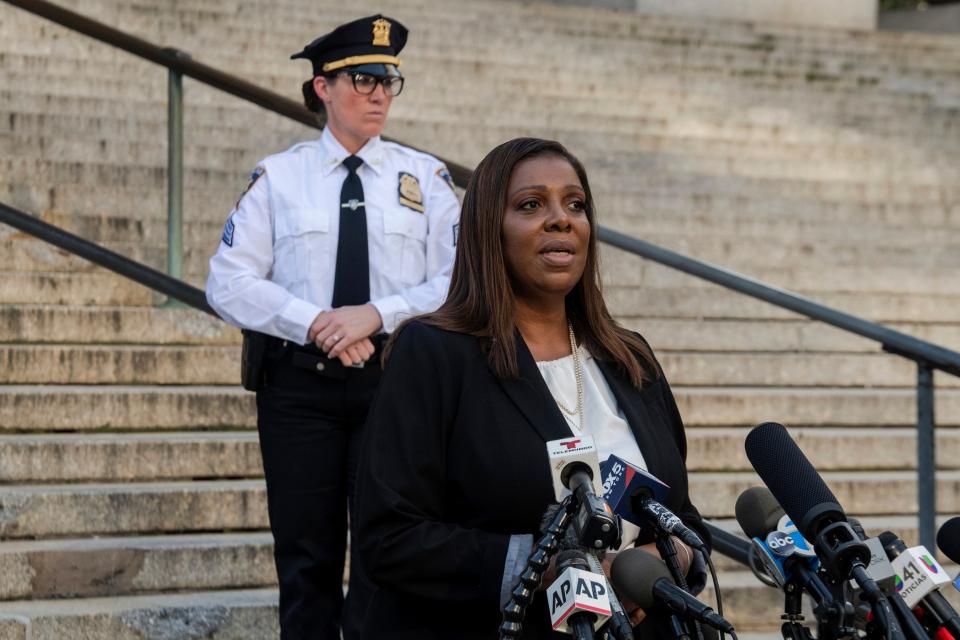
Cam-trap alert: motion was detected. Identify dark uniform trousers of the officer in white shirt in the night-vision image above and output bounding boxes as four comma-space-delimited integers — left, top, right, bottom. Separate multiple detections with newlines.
257, 340, 380, 640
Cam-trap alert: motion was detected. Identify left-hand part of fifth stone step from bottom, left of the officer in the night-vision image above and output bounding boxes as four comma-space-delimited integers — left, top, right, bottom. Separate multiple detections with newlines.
0, 385, 257, 433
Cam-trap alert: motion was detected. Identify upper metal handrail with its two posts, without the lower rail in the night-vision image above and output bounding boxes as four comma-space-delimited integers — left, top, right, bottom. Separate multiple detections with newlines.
3, 0, 960, 549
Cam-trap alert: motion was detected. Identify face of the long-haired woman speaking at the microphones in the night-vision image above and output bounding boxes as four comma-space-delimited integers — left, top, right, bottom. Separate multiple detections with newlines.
503, 155, 590, 302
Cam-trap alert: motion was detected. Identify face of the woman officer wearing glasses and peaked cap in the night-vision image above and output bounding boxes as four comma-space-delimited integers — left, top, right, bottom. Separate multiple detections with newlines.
313, 74, 393, 151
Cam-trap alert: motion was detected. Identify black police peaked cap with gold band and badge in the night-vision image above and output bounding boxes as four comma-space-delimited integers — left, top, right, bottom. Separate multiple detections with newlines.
290, 14, 407, 76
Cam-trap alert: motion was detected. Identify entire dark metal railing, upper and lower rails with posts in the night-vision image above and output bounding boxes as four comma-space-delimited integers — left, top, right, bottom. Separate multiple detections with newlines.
0, 0, 960, 557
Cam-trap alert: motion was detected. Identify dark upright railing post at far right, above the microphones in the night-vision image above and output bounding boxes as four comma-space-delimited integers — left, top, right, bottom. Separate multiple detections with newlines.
917, 360, 937, 553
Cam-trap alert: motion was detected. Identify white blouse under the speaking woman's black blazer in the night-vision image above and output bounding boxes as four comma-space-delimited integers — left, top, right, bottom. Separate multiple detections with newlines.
537, 346, 647, 550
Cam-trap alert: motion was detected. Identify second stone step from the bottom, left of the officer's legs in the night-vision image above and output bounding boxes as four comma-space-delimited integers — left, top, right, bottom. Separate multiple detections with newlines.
0, 532, 277, 604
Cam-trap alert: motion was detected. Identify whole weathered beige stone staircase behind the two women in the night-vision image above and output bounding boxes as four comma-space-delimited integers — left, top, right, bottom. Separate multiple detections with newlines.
0, 0, 960, 640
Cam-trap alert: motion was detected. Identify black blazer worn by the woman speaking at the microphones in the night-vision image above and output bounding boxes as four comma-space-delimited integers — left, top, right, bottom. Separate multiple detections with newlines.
355, 322, 709, 640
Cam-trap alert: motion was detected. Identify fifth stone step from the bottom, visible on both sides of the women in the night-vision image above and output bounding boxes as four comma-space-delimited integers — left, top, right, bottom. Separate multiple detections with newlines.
7, 382, 960, 433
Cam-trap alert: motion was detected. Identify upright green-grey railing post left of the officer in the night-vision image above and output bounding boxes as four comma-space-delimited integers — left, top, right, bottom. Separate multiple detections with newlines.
167, 49, 190, 306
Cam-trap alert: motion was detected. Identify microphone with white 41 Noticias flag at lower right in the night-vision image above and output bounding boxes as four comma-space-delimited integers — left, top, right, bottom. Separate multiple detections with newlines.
879, 531, 960, 637
